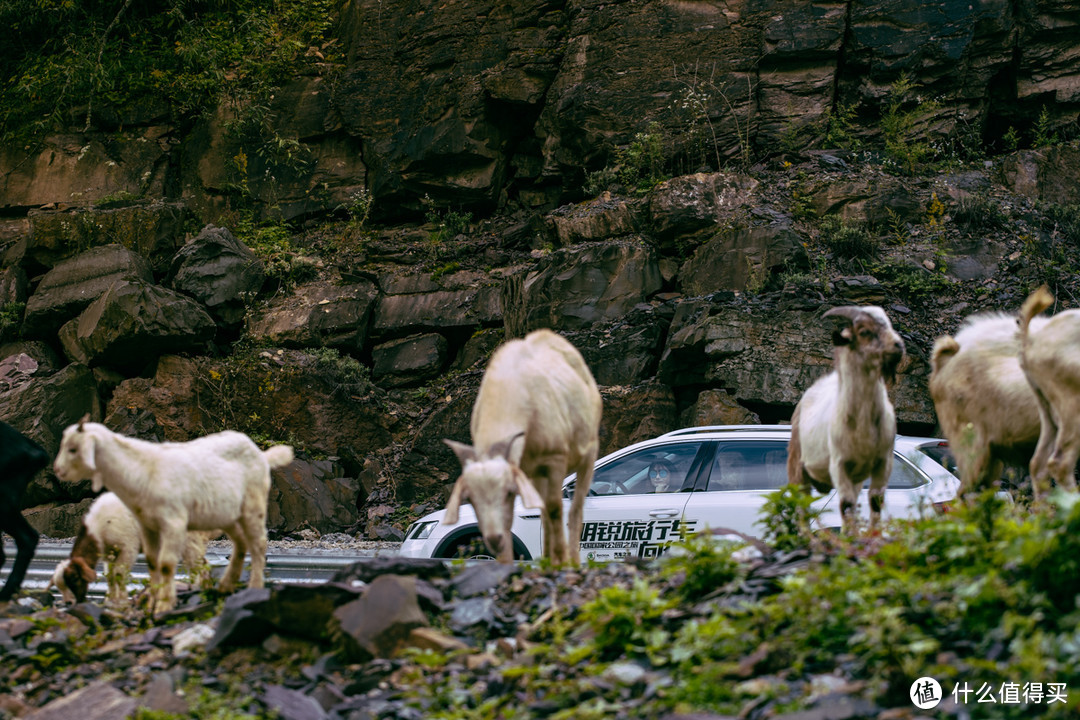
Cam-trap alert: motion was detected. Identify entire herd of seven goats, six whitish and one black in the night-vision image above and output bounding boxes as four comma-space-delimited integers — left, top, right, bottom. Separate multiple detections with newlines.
0, 287, 1080, 613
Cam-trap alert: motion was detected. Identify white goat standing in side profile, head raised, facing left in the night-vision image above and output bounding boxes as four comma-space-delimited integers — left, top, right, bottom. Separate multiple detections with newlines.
53, 421, 293, 612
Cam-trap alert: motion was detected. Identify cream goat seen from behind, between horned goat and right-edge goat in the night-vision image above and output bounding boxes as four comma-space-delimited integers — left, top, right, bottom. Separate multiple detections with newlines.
929, 313, 1045, 495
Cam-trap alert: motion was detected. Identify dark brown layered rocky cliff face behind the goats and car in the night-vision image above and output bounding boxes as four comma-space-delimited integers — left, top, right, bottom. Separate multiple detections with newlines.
0, 0, 1080, 539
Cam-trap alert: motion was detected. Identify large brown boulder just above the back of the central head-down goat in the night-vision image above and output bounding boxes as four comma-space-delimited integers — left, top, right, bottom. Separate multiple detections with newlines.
503, 241, 662, 336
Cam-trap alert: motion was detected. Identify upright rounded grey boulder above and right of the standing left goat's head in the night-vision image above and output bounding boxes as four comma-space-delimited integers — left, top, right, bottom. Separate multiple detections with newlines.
170, 225, 266, 325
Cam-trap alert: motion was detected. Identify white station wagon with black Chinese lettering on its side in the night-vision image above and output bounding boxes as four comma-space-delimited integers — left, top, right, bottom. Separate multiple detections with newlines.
401, 425, 960, 561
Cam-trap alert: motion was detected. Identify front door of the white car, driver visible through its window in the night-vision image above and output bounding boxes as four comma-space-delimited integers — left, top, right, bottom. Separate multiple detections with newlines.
565, 440, 714, 562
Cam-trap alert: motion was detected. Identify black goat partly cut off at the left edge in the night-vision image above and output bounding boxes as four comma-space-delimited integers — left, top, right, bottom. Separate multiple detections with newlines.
0, 421, 49, 602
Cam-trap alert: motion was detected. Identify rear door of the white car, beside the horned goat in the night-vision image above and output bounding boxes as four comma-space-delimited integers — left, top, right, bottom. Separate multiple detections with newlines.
684, 438, 787, 538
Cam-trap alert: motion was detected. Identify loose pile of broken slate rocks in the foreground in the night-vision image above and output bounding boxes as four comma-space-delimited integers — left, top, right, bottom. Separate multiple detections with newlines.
0, 545, 855, 720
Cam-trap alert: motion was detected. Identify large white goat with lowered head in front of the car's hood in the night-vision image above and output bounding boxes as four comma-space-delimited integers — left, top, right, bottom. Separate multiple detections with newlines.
443, 330, 602, 565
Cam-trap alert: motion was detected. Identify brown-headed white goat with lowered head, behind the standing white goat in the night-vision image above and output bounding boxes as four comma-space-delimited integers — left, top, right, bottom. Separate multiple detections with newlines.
52, 492, 219, 606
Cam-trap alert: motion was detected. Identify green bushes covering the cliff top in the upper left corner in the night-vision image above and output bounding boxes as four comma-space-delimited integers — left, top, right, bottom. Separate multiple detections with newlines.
0, 0, 333, 141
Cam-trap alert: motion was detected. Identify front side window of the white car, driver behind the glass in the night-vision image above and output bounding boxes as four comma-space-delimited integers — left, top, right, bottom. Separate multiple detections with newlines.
590, 443, 702, 495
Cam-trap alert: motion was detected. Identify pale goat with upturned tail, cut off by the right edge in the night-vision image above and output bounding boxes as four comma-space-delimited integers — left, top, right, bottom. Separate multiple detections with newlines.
1020, 285, 1080, 500
